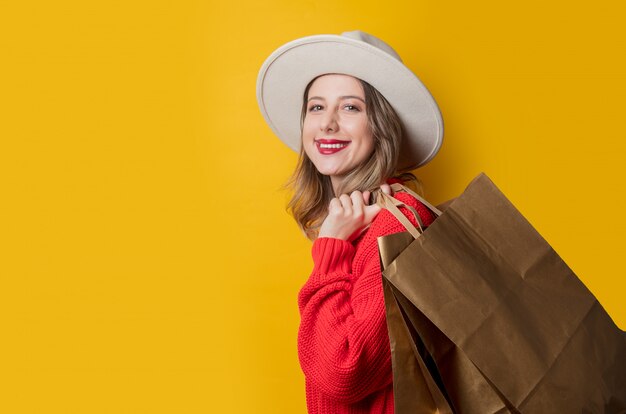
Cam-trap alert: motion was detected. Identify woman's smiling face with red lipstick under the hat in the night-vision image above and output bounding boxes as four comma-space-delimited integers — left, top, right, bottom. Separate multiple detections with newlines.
302, 74, 374, 188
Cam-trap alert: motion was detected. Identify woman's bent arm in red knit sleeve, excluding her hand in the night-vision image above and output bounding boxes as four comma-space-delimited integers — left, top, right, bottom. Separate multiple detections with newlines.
298, 234, 391, 403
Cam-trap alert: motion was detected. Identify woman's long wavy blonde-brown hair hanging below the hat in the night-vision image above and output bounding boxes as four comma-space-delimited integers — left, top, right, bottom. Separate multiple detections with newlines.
286, 74, 421, 240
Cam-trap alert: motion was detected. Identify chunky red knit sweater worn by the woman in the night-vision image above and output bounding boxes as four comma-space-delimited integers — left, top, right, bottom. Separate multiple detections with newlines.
298, 193, 435, 414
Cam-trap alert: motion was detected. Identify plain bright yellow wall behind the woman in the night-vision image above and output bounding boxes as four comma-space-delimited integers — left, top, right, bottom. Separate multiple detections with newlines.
0, 0, 626, 413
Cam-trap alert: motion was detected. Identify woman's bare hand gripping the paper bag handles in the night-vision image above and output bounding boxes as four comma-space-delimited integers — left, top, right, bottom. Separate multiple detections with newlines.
318, 184, 391, 241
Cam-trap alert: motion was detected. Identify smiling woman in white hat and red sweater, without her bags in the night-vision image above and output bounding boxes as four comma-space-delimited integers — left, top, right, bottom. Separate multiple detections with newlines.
257, 31, 443, 413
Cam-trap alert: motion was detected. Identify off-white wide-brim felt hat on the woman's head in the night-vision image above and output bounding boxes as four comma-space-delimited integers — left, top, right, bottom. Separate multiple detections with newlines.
257, 30, 443, 171
